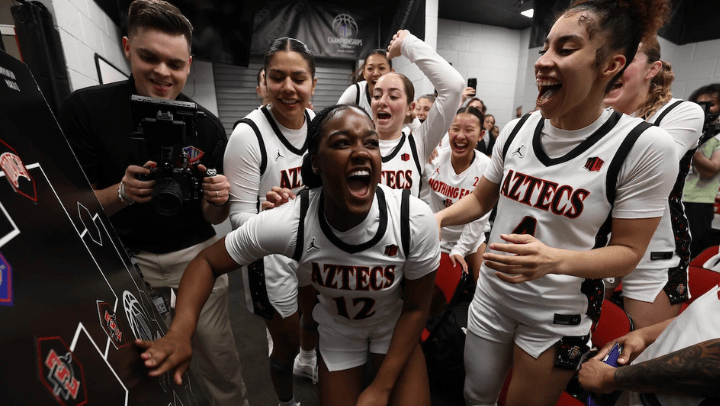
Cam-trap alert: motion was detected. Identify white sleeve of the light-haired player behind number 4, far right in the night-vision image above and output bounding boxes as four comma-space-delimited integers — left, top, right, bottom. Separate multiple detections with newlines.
660, 102, 705, 162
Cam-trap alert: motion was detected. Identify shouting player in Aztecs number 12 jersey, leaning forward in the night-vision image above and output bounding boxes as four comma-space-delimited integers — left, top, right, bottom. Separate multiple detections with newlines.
137, 105, 440, 406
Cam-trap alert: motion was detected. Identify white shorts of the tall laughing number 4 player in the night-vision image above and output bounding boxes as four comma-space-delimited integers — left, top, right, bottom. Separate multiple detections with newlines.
468, 285, 592, 358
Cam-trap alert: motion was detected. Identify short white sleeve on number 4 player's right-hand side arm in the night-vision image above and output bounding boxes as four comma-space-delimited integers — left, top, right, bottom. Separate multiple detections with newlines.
612, 127, 679, 219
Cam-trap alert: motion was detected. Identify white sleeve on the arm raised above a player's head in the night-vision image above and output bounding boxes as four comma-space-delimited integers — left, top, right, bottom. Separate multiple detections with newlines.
401, 34, 465, 162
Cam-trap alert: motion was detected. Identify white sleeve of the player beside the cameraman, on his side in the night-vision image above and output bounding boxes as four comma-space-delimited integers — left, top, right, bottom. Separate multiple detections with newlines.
223, 123, 264, 230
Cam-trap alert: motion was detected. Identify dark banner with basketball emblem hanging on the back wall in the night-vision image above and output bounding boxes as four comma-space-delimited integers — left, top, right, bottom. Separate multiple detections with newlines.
250, 1, 380, 59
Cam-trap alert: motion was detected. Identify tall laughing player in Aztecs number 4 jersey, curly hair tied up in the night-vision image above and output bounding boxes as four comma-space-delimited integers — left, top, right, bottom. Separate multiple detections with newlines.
436, 0, 678, 406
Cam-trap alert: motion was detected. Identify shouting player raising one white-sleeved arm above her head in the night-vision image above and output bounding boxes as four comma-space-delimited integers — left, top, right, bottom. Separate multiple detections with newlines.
372, 30, 465, 196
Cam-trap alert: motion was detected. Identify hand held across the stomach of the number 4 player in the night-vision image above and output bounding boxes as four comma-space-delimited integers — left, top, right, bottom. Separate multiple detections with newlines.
483, 234, 560, 283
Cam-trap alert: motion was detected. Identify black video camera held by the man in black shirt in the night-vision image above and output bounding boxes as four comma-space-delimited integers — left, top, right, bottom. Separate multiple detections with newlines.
130, 95, 216, 216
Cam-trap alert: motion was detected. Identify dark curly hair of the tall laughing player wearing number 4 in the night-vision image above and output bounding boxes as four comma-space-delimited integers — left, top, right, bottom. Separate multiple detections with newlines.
564, 0, 671, 93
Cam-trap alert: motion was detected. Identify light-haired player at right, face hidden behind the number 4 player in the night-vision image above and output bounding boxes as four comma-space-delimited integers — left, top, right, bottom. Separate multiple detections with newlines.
605, 38, 705, 329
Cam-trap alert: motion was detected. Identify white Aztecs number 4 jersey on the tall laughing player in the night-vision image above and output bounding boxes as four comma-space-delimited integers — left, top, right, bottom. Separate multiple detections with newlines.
480, 113, 649, 324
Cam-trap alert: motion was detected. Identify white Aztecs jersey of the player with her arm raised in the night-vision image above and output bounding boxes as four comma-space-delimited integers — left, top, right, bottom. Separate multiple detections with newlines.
380, 133, 423, 197
